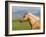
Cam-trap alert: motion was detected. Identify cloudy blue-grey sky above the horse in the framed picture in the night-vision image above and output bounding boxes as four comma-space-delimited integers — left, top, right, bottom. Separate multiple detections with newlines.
12, 6, 40, 16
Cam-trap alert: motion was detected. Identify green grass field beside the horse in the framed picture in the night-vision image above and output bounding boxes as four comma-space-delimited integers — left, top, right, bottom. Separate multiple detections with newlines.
12, 20, 31, 30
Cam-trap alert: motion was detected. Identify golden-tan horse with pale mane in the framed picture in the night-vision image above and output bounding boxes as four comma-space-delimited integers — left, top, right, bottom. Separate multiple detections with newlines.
23, 13, 40, 29
